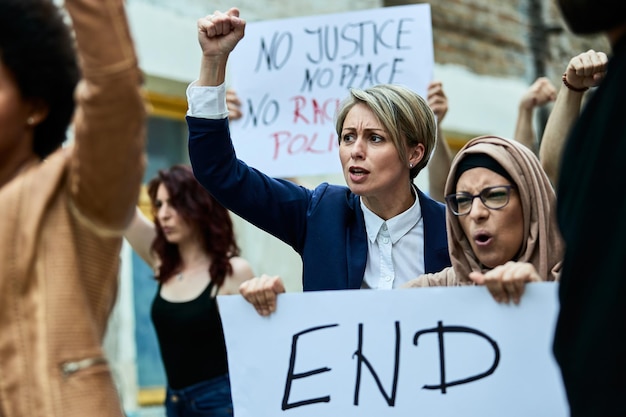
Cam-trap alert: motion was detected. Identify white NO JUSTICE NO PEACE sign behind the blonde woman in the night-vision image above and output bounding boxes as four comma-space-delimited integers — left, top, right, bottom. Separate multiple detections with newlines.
228, 4, 434, 177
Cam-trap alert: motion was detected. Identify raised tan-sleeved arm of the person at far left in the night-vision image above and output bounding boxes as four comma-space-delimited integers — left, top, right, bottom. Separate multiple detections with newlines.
65, 0, 146, 231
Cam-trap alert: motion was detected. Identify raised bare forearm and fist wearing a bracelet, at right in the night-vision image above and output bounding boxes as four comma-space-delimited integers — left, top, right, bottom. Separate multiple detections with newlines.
539, 49, 608, 186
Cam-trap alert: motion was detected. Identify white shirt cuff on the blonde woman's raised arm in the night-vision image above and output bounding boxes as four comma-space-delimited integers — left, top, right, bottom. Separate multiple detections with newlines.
187, 80, 228, 119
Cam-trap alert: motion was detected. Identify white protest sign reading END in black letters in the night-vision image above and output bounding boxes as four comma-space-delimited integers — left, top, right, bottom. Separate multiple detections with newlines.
218, 283, 568, 417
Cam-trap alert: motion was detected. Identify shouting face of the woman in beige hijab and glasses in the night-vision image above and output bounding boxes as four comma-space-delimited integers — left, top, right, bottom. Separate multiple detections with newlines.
456, 168, 524, 268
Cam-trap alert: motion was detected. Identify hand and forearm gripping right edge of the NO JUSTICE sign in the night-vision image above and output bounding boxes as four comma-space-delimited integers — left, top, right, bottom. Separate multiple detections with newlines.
427, 81, 452, 203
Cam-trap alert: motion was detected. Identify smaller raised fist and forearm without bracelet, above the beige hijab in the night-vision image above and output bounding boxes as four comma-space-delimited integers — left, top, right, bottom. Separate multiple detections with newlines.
513, 77, 557, 153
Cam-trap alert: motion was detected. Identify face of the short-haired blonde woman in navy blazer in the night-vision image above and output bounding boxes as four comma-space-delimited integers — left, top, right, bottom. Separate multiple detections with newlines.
339, 103, 410, 206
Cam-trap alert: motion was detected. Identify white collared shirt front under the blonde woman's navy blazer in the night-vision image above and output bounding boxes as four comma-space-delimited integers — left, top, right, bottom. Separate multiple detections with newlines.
361, 190, 425, 290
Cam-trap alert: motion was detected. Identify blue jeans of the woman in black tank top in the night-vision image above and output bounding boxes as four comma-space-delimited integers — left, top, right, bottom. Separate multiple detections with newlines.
165, 375, 233, 417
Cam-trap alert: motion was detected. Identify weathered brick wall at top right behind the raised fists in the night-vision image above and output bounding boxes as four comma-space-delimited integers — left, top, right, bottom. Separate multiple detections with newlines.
384, 0, 608, 85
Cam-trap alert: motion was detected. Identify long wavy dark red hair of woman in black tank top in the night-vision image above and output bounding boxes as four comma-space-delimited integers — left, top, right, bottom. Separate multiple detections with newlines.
148, 165, 240, 286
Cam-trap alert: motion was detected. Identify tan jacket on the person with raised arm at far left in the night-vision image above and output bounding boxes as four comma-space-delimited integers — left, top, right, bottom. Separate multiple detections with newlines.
0, 0, 145, 417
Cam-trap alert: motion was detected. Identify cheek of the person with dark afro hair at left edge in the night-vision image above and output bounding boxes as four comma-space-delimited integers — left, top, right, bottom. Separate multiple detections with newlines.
0, 60, 34, 172
